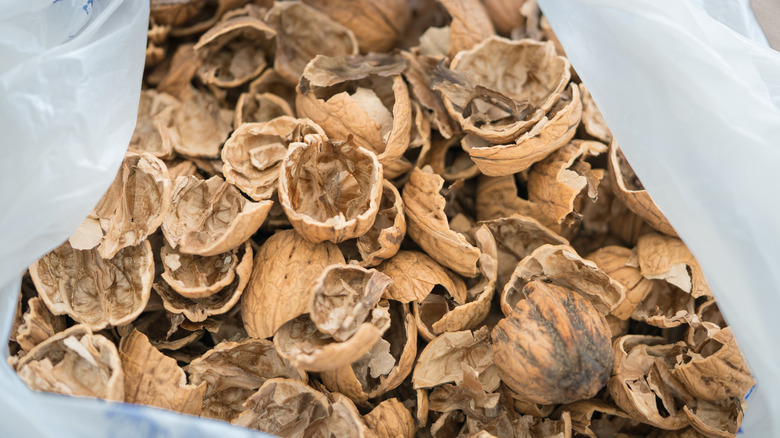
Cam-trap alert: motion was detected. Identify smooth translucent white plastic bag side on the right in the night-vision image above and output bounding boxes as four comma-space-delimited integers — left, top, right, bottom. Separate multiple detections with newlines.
539, 0, 780, 437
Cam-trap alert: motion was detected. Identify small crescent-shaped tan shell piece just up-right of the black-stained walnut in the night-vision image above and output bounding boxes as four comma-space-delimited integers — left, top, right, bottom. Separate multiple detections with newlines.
586, 245, 653, 319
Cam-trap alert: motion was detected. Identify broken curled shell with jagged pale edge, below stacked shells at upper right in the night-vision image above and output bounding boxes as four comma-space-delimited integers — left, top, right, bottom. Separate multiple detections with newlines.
528, 140, 607, 225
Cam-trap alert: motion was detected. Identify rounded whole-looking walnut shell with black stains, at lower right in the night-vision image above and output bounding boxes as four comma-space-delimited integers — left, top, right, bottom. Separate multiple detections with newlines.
492, 281, 613, 404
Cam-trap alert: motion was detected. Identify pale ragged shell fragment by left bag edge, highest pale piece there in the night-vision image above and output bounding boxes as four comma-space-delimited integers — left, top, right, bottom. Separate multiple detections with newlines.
127, 89, 181, 159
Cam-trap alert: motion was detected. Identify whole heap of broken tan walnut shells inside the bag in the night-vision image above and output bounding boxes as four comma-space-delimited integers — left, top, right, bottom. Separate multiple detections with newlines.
10, 0, 754, 438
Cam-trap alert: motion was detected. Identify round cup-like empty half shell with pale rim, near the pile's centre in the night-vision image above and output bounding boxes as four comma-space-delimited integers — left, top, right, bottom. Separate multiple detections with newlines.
279, 134, 382, 243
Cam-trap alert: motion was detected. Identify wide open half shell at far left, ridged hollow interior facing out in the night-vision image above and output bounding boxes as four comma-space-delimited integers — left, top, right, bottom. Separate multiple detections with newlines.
30, 240, 154, 330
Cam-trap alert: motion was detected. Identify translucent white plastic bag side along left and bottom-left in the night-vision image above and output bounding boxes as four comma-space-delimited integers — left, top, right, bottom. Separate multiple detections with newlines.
0, 0, 267, 438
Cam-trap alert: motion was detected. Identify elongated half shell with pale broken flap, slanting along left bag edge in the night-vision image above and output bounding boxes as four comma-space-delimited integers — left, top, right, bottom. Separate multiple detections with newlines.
68, 153, 171, 259
